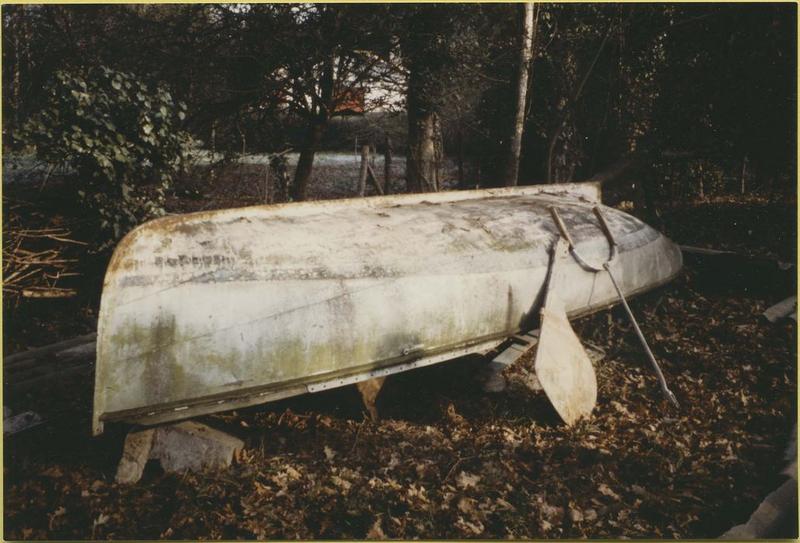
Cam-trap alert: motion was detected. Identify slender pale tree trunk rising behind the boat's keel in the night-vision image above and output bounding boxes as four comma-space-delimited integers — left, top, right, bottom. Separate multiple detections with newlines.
503, 2, 538, 187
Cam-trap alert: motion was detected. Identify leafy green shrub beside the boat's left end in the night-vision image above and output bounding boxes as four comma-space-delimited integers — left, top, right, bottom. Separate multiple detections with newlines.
22, 67, 191, 250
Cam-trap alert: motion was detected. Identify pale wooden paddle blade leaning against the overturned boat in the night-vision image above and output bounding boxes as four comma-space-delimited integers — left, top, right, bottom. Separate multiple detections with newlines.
533, 236, 597, 425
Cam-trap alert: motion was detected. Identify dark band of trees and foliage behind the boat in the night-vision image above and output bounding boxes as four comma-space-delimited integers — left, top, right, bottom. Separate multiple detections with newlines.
2, 4, 797, 202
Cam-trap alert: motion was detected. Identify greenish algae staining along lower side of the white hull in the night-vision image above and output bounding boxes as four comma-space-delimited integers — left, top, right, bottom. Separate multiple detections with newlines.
104, 282, 512, 410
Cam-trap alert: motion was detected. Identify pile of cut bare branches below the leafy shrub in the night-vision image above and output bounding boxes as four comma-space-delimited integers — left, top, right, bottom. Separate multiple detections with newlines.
3, 198, 86, 303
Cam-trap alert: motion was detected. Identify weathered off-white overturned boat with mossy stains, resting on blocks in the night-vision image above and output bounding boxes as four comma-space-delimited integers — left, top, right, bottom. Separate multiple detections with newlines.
93, 183, 682, 434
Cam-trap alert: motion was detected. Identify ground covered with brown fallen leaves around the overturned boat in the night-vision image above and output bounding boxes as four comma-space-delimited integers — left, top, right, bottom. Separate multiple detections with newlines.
4, 164, 797, 539
